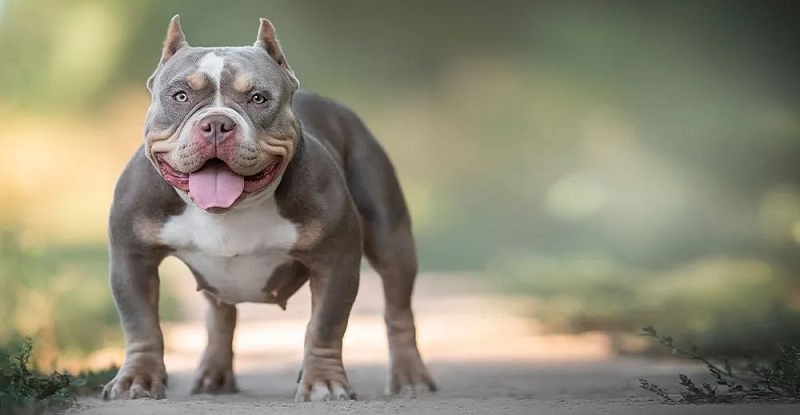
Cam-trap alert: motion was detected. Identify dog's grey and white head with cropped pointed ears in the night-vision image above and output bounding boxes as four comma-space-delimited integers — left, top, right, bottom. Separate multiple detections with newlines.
144, 16, 299, 212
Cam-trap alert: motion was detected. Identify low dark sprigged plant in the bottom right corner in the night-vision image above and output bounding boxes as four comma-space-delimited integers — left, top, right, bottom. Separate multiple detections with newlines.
639, 327, 800, 404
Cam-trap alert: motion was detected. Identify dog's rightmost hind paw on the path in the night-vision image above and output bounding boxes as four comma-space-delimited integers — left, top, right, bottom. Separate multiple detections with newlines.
386, 348, 439, 398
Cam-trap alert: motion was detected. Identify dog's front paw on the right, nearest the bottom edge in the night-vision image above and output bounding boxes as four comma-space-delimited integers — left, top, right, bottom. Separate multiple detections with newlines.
294, 362, 356, 402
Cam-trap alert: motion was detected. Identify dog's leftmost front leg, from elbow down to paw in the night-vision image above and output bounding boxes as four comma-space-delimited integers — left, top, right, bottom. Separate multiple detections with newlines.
103, 249, 167, 399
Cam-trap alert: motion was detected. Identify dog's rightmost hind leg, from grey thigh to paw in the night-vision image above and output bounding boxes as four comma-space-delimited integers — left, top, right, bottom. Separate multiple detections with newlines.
346, 131, 437, 396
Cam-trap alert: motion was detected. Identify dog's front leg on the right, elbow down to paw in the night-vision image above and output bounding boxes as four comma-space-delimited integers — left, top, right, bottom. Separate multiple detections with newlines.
295, 255, 359, 402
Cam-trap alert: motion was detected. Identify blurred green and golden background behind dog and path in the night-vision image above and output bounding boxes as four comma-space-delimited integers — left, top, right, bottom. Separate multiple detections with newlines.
0, 0, 800, 370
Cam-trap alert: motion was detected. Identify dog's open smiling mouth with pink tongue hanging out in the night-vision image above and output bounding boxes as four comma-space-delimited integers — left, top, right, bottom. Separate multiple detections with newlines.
158, 158, 281, 210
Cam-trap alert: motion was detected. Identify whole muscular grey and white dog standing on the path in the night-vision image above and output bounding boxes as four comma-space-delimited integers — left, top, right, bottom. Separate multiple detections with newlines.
103, 16, 436, 401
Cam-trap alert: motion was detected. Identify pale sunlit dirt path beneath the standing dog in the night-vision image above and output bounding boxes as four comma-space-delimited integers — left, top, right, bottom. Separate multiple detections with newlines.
74, 272, 797, 415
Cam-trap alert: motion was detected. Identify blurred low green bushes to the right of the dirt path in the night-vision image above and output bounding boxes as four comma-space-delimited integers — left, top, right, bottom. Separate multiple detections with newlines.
491, 255, 800, 357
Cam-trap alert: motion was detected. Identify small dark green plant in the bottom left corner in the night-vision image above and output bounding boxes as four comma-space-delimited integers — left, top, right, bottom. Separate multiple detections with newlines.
0, 337, 117, 415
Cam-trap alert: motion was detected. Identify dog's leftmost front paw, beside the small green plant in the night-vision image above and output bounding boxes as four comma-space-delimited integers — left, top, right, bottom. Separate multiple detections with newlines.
103, 357, 167, 400
